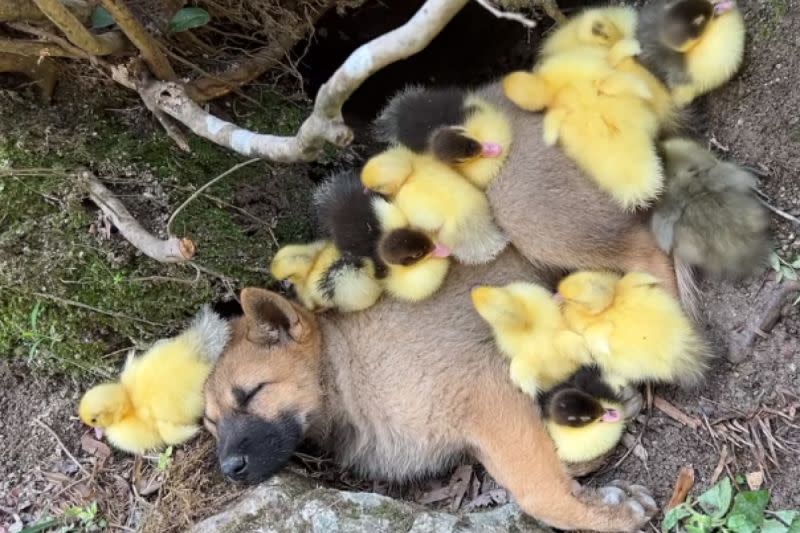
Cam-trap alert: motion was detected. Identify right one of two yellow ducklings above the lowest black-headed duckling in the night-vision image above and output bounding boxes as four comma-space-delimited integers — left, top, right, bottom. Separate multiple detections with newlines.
558, 271, 710, 389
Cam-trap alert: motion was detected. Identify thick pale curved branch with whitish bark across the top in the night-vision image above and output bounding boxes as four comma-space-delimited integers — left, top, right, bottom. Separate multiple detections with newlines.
139, 0, 469, 163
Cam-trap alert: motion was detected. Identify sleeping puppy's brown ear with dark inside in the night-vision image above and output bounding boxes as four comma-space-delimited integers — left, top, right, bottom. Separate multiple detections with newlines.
241, 287, 309, 344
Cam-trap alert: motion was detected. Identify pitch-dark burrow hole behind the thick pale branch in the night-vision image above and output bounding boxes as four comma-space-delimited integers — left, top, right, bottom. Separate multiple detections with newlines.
296, 0, 587, 133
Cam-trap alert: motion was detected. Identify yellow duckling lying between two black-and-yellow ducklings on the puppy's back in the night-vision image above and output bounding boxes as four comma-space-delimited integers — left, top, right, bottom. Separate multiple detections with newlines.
361, 146, 508, 264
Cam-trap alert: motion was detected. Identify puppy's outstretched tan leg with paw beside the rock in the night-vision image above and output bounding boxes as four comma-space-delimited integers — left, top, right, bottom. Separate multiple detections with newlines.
462, 386, 656, 531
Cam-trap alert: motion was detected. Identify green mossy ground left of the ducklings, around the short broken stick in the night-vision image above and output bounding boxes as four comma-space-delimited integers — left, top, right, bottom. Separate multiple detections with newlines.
0, 86, 312, 379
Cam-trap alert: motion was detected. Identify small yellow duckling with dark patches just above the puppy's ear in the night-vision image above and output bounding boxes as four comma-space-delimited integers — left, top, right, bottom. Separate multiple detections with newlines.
270, 240, 383, 312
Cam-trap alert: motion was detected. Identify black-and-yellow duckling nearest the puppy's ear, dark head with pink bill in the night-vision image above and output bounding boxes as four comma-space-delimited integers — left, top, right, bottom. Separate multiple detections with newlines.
314, 171, 450, 301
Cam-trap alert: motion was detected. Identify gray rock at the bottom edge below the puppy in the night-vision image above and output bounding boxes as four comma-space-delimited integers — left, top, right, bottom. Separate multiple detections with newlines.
192, 473, 552, 533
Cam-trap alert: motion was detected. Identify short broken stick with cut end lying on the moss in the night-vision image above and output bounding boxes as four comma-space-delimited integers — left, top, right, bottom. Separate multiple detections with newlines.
81, 172, 195, 263
